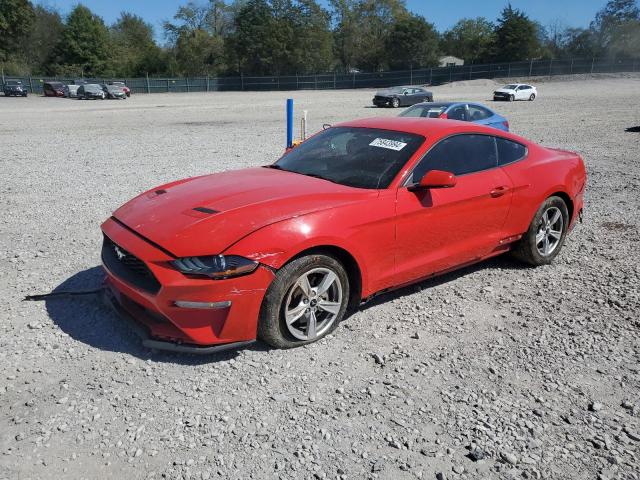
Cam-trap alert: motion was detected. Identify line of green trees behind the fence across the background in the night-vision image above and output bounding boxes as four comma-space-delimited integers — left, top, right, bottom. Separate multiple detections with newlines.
0, 0, 640, 77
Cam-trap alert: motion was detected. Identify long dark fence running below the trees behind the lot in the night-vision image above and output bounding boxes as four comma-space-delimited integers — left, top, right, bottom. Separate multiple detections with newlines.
2, 58, 640, 94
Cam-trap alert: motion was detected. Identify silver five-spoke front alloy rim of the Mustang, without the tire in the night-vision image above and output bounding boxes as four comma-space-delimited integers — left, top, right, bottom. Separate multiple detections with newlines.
284, 267, 343, 341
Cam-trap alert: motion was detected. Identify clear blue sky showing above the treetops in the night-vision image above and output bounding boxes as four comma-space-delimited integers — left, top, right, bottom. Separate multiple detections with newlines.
35, 0, 606, 40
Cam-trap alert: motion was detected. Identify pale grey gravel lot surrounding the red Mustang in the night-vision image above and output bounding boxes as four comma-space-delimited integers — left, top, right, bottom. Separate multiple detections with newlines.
0, 76, 640, 480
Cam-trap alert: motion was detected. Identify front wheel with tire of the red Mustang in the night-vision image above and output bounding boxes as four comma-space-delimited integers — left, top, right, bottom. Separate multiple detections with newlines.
258, 254, 349, 348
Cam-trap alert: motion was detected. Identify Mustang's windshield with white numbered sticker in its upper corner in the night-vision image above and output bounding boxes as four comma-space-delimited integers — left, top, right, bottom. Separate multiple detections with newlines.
271, 127, 424, 189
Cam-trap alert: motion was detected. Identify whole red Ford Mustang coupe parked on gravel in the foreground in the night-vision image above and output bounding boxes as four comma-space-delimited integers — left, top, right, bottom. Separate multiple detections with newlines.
102, 118, 586, 352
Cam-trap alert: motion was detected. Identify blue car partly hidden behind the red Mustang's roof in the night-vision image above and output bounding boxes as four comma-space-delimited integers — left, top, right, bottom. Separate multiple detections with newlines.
399, 102, 509, 132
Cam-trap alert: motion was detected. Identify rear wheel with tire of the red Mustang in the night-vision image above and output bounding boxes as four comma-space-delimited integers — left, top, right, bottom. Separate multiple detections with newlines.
513, 197, 569, 266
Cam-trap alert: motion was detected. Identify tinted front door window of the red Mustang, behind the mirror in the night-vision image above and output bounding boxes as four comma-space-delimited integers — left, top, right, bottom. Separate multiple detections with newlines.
407, 134, 498, 185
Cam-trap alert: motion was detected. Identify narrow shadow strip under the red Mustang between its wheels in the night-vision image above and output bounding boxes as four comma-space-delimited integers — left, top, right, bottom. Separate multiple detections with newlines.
358, 254, 533, 311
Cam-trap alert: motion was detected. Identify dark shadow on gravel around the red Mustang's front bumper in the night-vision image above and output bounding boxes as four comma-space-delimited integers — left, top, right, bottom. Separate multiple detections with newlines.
45, 267, 268, 365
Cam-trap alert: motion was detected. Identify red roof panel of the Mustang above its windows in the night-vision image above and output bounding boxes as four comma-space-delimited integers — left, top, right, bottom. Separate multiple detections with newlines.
334, 117, 531, 145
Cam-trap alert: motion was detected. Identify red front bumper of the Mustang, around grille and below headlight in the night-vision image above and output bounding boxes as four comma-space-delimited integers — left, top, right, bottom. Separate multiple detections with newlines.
102, 219, 274, 353
